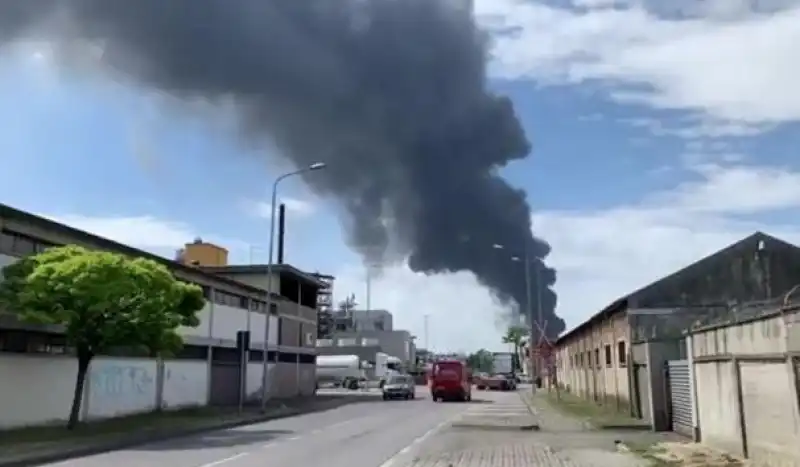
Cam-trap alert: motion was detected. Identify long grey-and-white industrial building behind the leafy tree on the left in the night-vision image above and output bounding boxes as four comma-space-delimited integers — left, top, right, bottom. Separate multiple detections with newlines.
0, 205, 325, 430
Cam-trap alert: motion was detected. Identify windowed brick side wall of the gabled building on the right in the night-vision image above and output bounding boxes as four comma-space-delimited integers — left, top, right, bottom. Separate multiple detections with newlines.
556, 313, 630, 411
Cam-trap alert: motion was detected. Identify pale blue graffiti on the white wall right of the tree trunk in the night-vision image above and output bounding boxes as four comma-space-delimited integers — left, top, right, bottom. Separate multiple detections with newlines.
90, 363, 156, 399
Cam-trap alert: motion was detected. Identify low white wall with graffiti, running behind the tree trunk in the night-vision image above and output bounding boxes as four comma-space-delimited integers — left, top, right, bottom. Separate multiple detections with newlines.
0, 354, 208, 428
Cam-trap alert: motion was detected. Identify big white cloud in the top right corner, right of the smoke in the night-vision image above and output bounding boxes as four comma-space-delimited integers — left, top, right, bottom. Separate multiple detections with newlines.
475, 0, 800, 125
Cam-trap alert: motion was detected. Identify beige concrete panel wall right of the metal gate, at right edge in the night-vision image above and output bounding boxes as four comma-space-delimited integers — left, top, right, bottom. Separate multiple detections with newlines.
691, 311, 800, 466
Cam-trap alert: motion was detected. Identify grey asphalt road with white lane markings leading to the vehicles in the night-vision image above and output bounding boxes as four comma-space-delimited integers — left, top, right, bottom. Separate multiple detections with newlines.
47, 387, 475, 467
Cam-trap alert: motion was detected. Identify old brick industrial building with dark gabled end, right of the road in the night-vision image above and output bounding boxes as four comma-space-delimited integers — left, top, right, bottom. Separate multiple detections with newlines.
555, 232, 800, 429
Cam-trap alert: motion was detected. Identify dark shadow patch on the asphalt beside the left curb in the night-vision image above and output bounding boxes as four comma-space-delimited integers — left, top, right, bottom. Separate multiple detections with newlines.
130, 427, 294, 451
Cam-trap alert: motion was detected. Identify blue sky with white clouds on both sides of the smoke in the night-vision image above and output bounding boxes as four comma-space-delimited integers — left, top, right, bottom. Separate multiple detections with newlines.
0, 0, 800, 350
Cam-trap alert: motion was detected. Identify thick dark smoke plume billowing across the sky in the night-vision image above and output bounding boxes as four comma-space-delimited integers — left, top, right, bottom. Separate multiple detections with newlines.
0, 0, 564, 337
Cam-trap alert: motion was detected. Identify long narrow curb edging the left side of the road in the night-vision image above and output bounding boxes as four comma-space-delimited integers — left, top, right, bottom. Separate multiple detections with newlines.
0, 404, 340, 467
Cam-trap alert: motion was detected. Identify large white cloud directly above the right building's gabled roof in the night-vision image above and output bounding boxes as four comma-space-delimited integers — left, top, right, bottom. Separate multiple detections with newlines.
534, 166, 800, 327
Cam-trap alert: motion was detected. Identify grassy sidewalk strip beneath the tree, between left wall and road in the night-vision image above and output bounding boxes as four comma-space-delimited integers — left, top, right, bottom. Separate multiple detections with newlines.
0, 396, 355, 467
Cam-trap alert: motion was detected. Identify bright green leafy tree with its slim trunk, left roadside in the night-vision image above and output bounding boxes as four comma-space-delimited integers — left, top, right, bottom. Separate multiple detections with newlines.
0, 246, 204, 429
